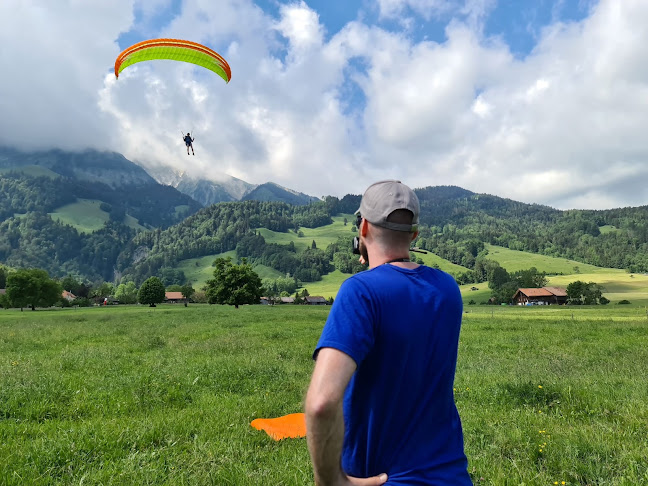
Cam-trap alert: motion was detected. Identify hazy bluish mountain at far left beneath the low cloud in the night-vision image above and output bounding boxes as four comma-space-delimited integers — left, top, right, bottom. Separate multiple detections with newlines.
0, 147, 200, 228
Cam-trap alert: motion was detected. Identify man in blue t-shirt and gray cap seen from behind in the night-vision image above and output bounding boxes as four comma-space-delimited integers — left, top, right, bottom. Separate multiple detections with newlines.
305, 181, 472, 486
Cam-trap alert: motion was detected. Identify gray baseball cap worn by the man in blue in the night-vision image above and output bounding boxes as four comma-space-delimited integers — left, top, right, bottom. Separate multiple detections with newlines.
355, 180, 420, 233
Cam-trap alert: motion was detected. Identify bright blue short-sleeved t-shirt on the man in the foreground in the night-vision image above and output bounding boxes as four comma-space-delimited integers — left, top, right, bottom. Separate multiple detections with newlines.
314, 265, 472, 486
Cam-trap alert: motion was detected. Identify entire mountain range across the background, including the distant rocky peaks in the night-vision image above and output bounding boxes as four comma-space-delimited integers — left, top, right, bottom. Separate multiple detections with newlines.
0, 148, 648, 283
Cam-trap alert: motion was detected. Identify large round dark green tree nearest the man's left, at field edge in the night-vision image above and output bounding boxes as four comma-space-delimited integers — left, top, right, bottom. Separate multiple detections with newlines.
205, 258, 262, 309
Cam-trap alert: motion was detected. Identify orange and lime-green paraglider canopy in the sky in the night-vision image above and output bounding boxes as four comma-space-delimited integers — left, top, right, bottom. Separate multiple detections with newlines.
115, 39, 232, 83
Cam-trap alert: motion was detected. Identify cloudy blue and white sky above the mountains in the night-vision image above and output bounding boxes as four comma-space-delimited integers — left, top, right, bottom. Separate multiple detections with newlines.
0, 0, 648, 209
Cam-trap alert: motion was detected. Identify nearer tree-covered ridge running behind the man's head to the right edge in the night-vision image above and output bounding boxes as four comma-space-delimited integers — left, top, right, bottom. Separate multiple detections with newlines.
118, 184, 648, 283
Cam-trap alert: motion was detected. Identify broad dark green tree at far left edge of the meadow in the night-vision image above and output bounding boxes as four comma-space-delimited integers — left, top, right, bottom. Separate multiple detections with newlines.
7, 268, 62, 310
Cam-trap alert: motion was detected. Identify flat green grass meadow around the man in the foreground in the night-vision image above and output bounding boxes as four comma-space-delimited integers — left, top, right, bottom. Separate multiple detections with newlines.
0, 305, 648, 486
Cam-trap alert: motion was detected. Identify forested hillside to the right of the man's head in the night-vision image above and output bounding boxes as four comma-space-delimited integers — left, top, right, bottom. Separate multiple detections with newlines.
416, 187, 648, 272
